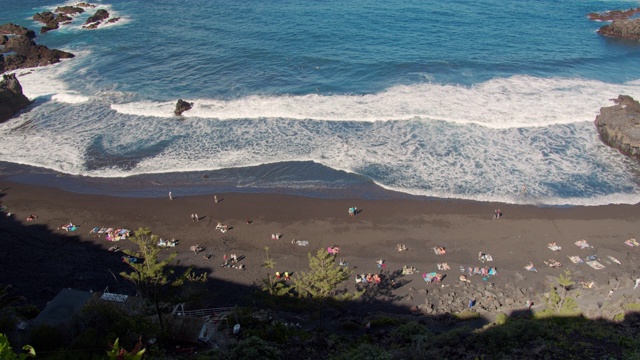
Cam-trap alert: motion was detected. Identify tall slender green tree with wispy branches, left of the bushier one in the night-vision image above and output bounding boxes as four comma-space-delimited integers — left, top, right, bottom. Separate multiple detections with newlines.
120, 228, 206, 332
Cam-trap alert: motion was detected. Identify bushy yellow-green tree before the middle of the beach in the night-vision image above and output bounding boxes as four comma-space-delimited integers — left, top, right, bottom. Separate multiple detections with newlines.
293, 249, 364, 303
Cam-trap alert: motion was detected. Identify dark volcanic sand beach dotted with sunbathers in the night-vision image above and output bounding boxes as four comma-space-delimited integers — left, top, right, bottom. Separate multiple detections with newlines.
0, 181, 640, 313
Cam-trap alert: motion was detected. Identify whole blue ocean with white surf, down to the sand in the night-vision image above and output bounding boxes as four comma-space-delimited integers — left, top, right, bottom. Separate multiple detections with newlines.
0, 0, 640, 206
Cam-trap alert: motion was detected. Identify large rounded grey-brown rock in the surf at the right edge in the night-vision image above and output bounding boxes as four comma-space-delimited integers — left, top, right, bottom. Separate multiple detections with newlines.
595, 95, 640, 159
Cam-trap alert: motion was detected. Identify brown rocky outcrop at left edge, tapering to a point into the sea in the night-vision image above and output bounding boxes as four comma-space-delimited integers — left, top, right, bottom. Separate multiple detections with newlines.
0, 35, 74, 73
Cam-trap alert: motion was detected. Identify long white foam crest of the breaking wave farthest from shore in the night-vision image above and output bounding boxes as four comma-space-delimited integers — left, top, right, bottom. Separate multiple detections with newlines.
112, 76, 640, 129
